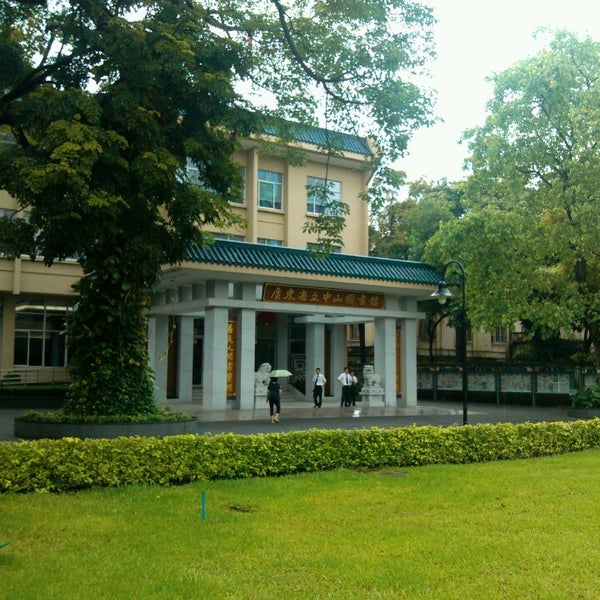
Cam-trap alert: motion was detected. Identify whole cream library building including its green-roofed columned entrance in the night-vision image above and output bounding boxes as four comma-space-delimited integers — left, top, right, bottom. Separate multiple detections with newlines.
0, 129, 439, 409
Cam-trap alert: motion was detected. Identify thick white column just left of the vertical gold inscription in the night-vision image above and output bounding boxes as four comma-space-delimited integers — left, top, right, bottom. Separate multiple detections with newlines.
202, 281, 229, 410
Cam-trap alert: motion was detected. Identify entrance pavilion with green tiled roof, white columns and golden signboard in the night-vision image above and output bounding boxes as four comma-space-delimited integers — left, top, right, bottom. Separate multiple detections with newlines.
149, 240, 439, 410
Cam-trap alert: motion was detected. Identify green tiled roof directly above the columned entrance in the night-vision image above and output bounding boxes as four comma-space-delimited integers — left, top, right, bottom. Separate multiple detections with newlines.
187, 240, 440, 286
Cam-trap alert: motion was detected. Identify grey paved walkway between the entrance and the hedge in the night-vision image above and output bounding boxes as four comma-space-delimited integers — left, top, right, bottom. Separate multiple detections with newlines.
0, 397, 575, 441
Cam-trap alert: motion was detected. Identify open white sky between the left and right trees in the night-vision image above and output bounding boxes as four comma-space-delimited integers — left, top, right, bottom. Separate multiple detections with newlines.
398, 0, 600, 181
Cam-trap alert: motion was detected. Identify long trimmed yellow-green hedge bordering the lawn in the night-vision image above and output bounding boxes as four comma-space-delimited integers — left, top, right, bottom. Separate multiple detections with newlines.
0, 419, 600, 492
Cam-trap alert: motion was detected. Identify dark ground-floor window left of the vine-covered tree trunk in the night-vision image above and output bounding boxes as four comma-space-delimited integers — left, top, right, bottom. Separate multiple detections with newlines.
14, 300, 67, 367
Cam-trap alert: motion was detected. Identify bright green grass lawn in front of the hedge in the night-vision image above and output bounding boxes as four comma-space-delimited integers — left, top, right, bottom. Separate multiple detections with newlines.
0, 450, 600, 600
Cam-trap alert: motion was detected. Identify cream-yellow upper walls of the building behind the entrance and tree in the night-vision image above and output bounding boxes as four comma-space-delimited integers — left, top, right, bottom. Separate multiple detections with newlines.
0, 140, 370, 376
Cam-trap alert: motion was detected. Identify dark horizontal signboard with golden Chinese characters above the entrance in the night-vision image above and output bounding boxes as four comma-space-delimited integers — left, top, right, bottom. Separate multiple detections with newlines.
262, 283, 385, 309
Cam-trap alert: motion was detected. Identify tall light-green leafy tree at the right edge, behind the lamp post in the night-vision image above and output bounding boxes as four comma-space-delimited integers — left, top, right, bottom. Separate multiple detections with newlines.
426, 32, 600, 366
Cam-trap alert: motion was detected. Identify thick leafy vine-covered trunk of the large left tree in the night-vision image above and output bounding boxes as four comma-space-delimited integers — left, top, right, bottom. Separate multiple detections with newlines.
66, 246, 160, 416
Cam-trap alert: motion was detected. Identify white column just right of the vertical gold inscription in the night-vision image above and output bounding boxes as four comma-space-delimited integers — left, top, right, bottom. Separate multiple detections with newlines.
234, 283, 256, 410
